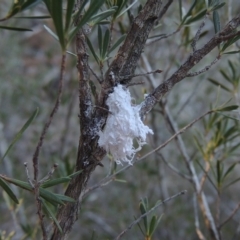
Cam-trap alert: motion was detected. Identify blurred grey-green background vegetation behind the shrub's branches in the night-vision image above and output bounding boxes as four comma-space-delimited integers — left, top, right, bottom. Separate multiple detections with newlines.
0, 0, 240, 240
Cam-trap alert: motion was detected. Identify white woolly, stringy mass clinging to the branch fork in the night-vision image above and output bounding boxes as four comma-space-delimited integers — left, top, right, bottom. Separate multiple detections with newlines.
98, 85, 153, 164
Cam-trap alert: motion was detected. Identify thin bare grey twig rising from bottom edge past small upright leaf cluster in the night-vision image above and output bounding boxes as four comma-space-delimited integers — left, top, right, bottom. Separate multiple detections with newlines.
115, 190, 187, 240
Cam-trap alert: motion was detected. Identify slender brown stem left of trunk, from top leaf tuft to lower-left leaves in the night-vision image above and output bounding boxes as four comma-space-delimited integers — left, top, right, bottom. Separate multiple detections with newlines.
32, 54, 66, 182
